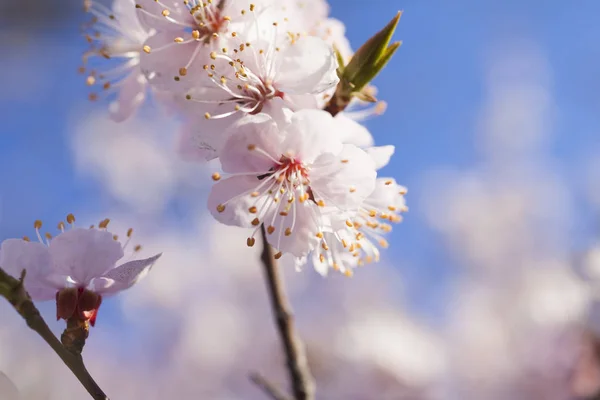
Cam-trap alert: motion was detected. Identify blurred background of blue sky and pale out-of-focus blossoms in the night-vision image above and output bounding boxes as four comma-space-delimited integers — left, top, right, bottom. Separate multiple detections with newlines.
0, 0, 600, 400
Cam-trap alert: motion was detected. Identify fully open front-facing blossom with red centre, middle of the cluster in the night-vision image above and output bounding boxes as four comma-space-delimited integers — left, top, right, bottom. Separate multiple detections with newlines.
208, 110, 376, 257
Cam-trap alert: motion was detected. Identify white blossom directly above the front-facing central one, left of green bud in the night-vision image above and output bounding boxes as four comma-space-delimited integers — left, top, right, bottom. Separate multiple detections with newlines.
176, 4, 339, 160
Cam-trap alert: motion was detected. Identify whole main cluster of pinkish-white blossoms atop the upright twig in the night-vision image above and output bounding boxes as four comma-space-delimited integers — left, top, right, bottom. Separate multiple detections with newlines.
82, 0, 407, 275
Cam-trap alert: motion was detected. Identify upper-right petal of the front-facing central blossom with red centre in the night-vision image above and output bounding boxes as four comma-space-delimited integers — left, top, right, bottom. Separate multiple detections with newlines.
281, 110, 342, 164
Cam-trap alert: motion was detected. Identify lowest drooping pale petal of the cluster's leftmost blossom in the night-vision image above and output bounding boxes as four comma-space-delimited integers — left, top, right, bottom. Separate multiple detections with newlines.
109, 68, 146, 122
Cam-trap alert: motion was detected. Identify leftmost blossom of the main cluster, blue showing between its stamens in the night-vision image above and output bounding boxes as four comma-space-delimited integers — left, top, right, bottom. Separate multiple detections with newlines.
81, 0, 152, 122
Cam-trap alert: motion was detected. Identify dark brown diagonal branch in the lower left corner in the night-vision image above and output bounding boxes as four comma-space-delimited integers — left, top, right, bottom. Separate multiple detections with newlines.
0, 268, 109, 400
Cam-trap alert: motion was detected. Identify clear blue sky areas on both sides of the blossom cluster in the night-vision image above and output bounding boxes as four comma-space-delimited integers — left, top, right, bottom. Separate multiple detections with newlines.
0, 0, 600, 320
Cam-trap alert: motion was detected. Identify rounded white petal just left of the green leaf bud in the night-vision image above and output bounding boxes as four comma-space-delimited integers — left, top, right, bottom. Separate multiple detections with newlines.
274, 36, 339, 94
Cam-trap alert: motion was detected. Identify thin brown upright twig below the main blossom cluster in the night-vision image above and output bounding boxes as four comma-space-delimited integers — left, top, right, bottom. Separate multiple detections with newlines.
261, 226, 315, 400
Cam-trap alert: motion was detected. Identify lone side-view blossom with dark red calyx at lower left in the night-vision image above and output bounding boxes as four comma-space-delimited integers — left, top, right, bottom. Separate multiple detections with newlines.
0, 214, 161, 325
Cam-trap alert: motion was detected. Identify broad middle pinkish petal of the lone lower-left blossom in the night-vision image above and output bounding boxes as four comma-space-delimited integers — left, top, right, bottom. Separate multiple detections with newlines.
49, 228, 123, 286
